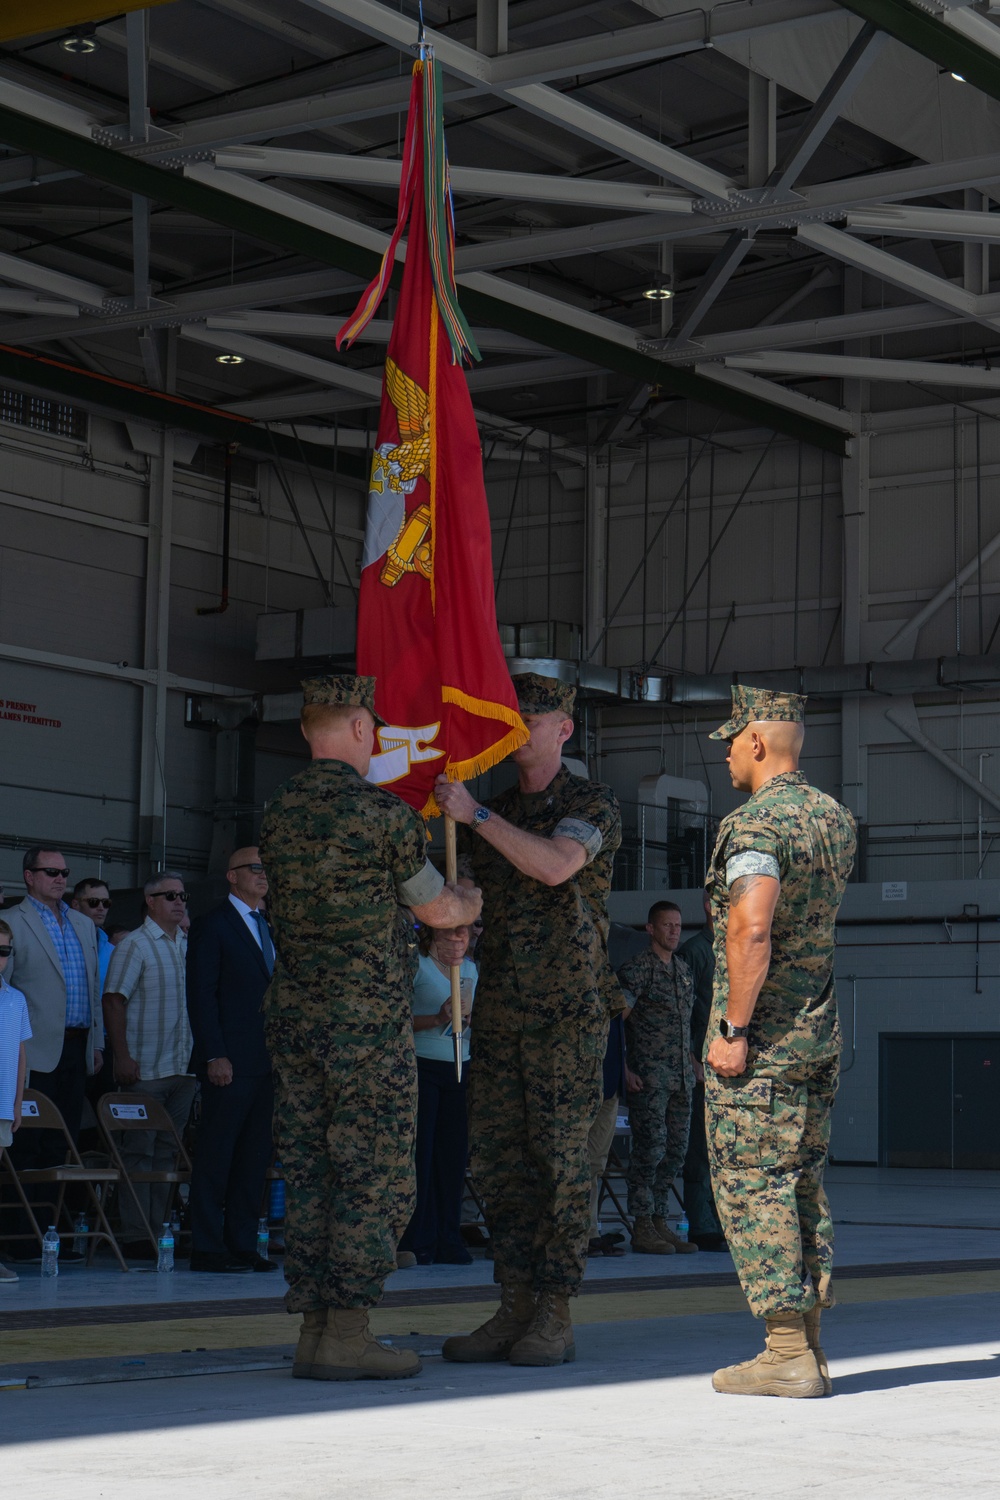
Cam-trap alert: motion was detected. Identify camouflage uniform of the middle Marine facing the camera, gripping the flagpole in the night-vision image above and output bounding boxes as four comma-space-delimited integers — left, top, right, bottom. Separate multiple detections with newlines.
465, 770, 621, 1295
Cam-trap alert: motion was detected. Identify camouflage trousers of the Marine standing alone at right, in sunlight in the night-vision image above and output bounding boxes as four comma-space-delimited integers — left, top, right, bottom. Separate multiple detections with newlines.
705, 1058, 840, 1317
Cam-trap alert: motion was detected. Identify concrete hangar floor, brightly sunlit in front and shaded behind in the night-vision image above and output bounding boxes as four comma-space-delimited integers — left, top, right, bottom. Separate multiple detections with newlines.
0, 1167, 1000, 1500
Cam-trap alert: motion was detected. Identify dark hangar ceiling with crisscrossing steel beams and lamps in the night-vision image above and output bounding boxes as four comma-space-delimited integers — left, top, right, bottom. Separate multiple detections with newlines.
0, 0, 1000, 452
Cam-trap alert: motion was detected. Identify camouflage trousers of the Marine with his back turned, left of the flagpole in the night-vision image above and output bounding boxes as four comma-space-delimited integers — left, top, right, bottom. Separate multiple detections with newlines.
267, 1017, 417, 1313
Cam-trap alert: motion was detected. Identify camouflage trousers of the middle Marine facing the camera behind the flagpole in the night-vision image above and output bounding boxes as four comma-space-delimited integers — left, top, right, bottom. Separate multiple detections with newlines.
469, 1022, 607, 1296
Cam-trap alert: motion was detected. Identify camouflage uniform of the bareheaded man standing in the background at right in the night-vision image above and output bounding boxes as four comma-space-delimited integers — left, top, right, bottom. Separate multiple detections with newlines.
618, 948, 694, 1218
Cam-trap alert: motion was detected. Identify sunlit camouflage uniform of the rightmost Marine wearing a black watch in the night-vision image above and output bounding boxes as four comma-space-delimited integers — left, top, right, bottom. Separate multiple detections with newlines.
705, 768, 856, 1317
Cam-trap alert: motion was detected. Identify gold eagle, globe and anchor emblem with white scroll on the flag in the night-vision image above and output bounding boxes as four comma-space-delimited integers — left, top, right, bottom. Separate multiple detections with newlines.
361, 359, 444, 786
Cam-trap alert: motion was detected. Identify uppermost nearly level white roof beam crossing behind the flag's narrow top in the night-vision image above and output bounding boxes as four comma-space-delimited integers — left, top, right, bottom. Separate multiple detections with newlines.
214, 146, 694, 213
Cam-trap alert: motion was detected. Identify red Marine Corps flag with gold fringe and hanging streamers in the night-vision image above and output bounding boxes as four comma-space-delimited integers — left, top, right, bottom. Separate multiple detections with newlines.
337, 56, 528, 816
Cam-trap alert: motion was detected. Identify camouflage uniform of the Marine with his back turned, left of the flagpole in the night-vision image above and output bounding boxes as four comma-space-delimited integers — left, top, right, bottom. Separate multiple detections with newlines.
259, 761, 442, 1313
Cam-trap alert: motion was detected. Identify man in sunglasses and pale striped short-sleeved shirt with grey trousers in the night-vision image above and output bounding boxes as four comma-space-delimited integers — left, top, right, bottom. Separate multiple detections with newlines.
103, 870, 196, 1260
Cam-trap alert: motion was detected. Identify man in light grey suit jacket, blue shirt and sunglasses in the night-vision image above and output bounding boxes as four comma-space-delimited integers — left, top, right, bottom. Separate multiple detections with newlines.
4, 848, 103, 1146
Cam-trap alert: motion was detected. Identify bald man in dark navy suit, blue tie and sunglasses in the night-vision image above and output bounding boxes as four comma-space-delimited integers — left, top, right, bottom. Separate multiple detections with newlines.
187, 848, 277, 1272
